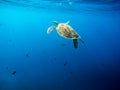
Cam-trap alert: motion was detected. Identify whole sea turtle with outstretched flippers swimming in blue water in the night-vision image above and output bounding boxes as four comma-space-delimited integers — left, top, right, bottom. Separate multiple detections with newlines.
47, 21, 81, 48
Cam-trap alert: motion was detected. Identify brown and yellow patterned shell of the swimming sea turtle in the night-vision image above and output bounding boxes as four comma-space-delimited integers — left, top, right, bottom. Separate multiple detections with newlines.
56, 23, 80, 39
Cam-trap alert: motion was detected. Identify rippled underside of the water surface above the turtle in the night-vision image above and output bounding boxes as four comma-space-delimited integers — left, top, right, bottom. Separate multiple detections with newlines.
0, 0, 120, 11
